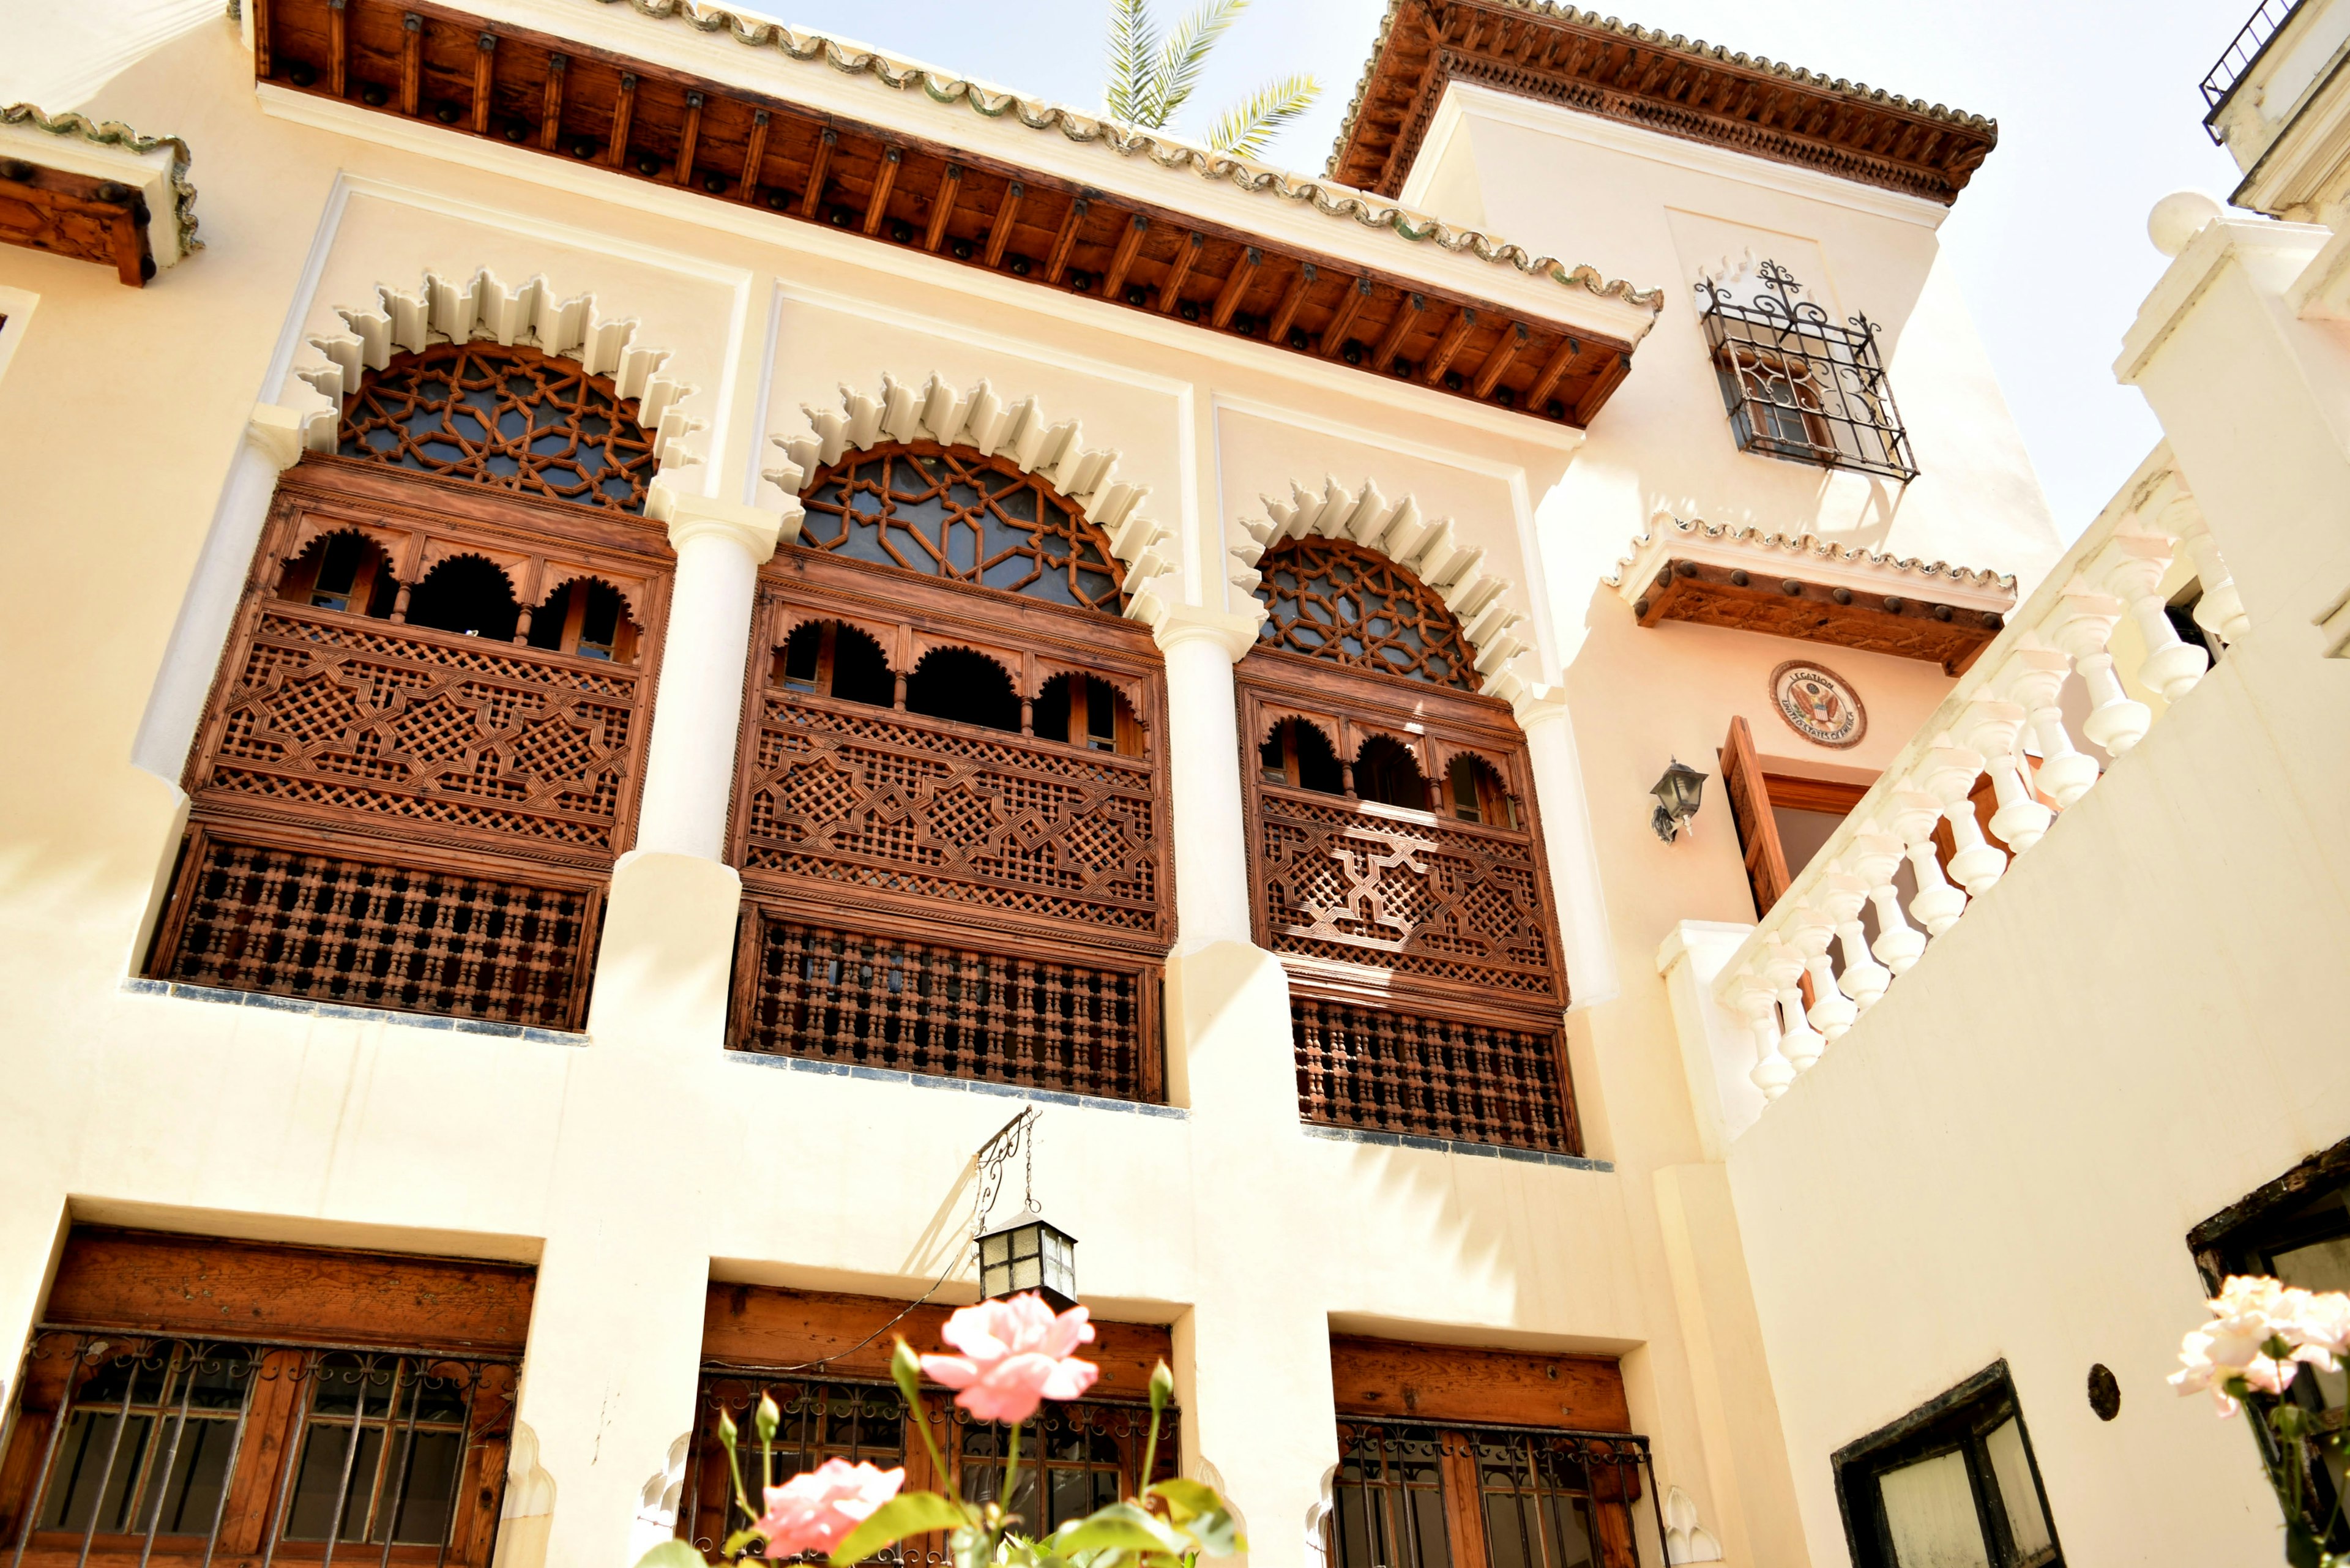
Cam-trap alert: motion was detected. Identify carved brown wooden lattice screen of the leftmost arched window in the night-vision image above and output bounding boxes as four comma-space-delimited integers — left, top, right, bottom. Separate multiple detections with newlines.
151, 404, 672, 1028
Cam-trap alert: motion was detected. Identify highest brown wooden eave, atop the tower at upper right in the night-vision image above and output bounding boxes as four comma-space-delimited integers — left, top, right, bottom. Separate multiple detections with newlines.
1330, 0, 2000, 204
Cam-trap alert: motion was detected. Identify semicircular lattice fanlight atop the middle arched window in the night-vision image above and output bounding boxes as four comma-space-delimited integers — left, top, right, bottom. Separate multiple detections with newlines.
799, 442, 1125, 614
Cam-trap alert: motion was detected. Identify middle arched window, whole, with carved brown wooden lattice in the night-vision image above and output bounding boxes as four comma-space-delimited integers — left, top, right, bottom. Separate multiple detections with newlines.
731, 442, 1175, 1100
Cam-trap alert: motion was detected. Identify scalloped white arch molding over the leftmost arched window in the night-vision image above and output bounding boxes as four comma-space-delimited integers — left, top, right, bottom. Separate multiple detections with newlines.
294, 268, 705, 477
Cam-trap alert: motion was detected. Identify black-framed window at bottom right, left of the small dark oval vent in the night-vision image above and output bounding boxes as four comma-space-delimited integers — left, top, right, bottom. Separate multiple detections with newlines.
1833, 1361, 2064, 1568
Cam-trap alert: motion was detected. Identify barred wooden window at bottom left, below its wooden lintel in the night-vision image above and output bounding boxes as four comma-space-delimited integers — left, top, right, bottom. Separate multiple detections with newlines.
0, 1328, 515, 1568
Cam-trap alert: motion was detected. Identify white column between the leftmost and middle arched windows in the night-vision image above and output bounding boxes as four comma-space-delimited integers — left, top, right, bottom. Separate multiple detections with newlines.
635, 484, 801, 861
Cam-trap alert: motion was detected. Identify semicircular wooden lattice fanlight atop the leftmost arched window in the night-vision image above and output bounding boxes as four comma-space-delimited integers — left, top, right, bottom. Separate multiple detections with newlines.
336, 343, 655, 512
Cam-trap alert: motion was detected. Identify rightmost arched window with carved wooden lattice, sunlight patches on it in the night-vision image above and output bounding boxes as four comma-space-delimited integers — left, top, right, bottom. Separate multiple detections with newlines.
1239, 539, 1579, 1152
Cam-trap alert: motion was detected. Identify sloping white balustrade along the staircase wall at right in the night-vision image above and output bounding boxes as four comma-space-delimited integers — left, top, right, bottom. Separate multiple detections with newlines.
1715, 460, 2251, 1100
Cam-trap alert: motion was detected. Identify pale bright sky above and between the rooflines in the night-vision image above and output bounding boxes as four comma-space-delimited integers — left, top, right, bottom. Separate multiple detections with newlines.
761, 0, 2254, 539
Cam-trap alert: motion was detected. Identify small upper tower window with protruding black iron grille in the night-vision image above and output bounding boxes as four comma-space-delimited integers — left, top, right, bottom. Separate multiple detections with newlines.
1696, 261, 1917, 484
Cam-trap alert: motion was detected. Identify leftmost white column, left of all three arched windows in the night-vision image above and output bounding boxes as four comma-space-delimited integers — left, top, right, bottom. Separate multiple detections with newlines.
132, 402, 303, 788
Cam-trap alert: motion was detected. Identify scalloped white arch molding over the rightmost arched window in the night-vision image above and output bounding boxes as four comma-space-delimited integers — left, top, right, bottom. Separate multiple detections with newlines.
1231, 477, 1532, 705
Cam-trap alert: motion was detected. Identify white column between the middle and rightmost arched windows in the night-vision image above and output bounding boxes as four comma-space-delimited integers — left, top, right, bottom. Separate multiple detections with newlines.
1152, 604, 1257, 950
